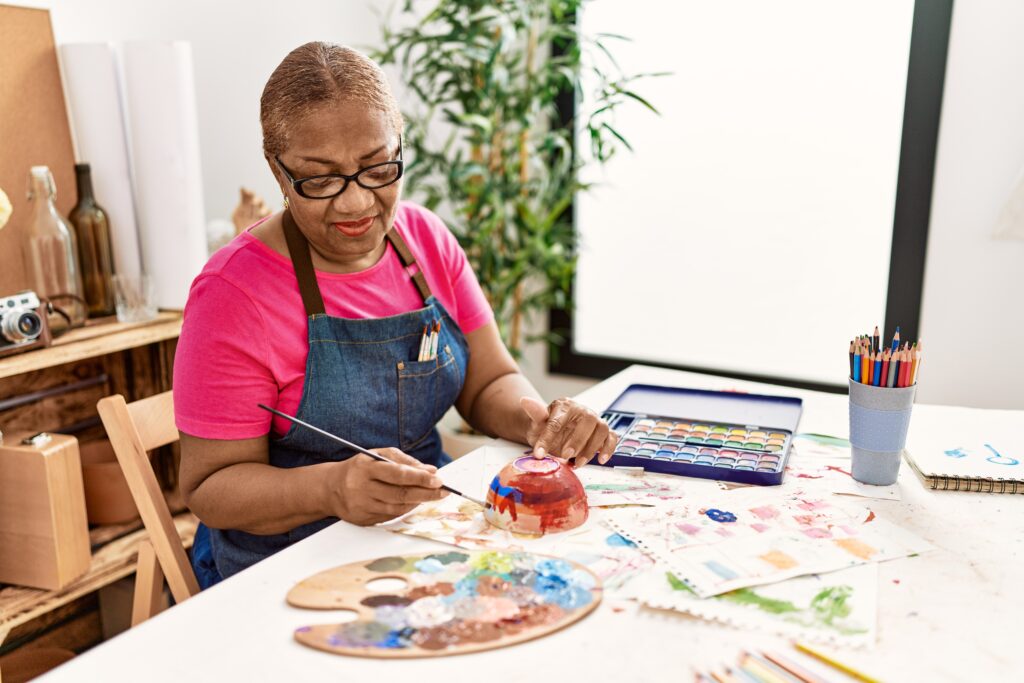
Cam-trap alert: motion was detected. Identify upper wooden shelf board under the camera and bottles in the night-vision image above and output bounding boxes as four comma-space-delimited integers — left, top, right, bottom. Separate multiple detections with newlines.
0, 311, 181, 379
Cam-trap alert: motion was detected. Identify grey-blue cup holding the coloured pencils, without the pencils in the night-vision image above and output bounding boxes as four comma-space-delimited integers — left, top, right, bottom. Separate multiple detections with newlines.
850, 379, 918, 486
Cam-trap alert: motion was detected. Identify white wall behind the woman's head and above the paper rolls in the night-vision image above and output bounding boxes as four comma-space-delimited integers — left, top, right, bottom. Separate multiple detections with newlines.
13, 0, 388, 228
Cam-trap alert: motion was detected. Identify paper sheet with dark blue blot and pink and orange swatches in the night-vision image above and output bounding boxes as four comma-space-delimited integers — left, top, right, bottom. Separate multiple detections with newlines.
608, 488, 932, 598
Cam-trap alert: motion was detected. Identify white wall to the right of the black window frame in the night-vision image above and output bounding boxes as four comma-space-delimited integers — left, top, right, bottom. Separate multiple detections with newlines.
918, 0, 1024, 409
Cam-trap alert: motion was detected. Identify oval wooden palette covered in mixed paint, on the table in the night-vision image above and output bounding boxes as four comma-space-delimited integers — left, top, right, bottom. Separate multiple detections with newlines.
288, 550, 602, 658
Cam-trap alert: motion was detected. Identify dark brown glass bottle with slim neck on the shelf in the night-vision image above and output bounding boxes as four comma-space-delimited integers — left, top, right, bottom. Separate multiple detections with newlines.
68, 164, 114, 316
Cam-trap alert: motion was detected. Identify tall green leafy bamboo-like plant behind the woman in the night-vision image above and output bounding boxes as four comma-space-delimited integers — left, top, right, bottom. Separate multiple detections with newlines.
373, 0, 656, 356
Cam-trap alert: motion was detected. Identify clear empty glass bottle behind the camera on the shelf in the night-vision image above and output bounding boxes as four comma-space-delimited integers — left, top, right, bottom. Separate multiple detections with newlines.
22, 166, 85, 325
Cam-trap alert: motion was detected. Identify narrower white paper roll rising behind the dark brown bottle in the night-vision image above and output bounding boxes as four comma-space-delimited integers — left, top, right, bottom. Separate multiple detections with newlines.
60, 43, 141, 275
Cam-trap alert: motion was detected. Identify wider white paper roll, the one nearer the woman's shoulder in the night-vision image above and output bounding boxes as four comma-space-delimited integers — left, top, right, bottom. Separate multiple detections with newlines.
120, 41, 207, 308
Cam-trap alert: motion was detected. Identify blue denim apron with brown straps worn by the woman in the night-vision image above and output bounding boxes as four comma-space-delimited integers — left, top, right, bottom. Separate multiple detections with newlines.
194, 210, 469, 587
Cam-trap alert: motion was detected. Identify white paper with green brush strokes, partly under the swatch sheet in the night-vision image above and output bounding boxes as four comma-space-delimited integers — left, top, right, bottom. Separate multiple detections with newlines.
624, 558, 878, 647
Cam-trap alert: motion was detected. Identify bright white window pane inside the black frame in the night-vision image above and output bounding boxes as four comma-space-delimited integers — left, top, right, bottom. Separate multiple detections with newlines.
572, 0, 913, 384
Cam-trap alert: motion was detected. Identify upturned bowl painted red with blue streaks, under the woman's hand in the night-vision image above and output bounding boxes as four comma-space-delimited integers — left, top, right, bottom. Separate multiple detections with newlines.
483, 456, 588, 536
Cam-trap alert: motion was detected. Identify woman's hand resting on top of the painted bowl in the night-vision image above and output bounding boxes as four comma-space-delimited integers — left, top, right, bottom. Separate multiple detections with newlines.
519, 396, 618, 467
